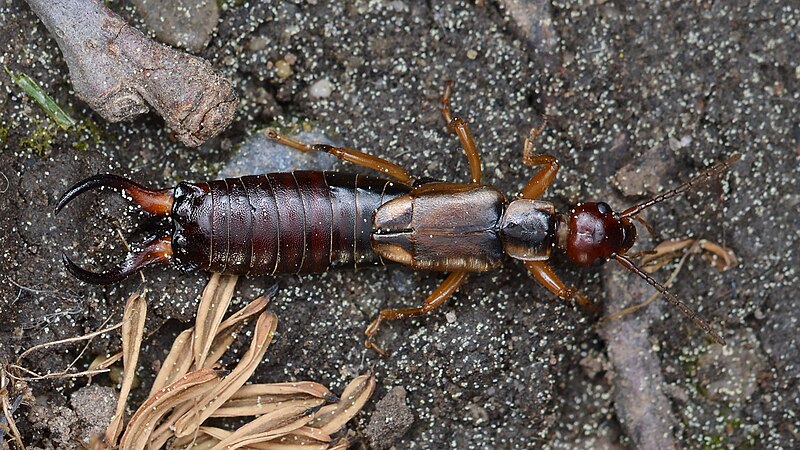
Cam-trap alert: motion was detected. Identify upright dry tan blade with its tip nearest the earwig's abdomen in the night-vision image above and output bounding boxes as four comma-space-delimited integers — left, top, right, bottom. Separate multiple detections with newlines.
192, 273, 238, 369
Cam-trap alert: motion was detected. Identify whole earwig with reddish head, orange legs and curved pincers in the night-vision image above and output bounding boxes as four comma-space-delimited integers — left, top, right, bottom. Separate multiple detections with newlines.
55, 82, 739, 354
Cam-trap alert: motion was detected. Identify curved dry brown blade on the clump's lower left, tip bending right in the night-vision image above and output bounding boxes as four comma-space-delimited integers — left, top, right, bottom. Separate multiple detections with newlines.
120, 369, 220, 450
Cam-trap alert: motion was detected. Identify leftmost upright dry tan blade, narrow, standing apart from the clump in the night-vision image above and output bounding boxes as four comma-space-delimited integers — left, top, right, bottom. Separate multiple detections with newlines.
105, 293, 147, 447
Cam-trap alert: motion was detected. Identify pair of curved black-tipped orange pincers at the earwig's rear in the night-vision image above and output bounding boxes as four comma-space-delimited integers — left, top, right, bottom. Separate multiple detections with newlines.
55, 174, 174, 284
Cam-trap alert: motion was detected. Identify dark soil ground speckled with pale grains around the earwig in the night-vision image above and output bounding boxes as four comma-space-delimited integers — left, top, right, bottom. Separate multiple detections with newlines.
0, 0, 800, 449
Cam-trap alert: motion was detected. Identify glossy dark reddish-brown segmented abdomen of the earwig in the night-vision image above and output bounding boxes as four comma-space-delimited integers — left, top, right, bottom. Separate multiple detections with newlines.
172, 171, 410, 275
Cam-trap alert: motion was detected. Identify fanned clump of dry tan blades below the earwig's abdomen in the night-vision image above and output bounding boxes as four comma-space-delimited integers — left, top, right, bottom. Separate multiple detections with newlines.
106, 275, 375, 450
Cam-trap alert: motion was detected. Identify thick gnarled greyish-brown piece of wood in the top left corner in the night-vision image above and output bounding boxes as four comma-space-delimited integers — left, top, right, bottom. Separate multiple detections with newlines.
27, 0, 237, 147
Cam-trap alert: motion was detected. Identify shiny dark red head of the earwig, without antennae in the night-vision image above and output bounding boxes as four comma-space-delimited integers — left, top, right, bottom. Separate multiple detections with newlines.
565, 202, 636, 266
